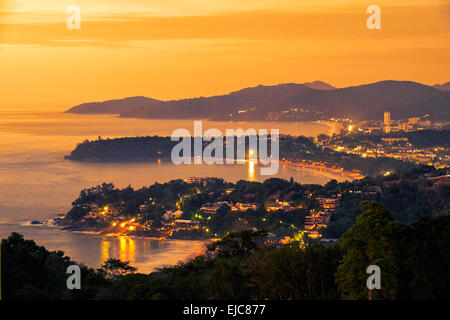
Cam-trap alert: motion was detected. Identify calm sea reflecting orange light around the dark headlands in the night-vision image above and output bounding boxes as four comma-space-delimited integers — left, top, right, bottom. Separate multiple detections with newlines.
0, 110, 345, 272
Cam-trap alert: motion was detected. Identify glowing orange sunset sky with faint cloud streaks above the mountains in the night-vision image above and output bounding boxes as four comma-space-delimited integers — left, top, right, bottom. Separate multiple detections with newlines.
0, 0, 450, 110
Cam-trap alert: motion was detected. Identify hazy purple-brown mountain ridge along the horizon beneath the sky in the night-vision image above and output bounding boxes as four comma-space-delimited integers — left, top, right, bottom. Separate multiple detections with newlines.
66, 80, 450, 121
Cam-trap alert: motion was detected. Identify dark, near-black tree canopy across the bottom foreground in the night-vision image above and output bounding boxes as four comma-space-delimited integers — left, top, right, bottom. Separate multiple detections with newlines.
1, 201, 450, 300
